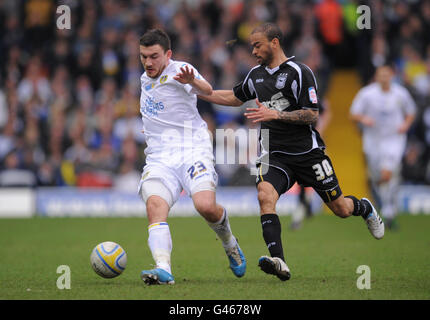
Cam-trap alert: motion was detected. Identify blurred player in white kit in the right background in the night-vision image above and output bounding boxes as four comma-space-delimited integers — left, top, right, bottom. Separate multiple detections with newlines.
350, 66, 416, 228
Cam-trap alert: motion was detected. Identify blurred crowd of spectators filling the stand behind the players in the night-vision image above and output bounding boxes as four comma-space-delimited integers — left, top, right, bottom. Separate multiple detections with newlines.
0, 0, 430, 191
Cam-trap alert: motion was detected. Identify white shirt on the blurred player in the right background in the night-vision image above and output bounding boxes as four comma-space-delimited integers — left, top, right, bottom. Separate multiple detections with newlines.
350, 83, 416, 153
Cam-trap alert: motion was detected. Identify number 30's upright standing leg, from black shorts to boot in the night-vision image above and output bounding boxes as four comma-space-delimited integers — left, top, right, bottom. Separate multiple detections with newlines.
257, 163, 294, 281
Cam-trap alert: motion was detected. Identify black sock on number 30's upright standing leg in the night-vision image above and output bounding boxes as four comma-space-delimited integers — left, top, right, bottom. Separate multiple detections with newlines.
261, 213, 285, 261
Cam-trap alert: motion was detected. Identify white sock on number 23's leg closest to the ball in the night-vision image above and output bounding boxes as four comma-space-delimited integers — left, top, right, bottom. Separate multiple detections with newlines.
148, 222, 172, 274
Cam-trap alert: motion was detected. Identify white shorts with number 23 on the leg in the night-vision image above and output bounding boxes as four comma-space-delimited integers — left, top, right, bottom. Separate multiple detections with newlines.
138, 152, 218, 207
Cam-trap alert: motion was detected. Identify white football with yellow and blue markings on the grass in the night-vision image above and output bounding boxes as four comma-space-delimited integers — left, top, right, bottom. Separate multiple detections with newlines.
90, 241, 127, 278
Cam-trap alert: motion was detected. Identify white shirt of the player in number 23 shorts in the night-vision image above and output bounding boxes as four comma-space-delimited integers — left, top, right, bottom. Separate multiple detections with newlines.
140, 60, 212, 162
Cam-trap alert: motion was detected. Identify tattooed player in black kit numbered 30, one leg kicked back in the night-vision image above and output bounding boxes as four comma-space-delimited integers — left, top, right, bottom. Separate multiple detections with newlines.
199, 23, 384, 281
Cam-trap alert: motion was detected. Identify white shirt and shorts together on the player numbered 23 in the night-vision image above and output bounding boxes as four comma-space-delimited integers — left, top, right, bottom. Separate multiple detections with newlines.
140, 60, 218, 207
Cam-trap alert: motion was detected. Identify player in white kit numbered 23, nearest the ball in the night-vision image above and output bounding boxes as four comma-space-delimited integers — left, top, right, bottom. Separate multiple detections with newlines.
139, 29, 246, 285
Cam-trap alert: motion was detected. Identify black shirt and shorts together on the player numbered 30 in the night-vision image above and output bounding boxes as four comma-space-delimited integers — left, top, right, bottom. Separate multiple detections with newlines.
233, 57, 342, 202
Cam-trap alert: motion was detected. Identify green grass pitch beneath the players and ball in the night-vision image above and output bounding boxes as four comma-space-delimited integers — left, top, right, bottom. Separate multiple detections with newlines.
0, 215, 430, 300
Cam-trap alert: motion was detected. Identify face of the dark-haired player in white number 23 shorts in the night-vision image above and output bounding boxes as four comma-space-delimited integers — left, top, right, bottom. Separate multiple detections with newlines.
140, 44, 172, 78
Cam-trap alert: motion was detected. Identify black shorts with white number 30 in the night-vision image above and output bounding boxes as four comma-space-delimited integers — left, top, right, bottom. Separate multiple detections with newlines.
257, 149, 342, 202
